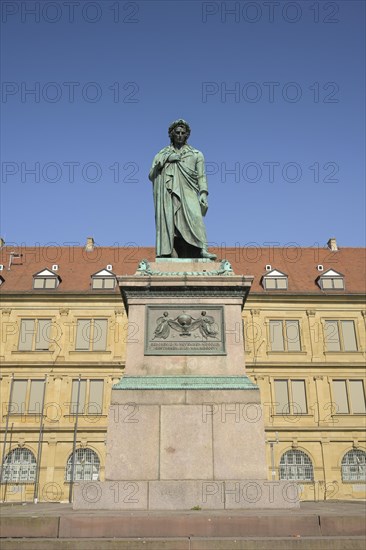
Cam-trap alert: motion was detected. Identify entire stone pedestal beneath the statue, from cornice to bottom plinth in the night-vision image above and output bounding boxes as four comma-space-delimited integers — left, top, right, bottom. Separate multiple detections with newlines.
74, 260, 298, 510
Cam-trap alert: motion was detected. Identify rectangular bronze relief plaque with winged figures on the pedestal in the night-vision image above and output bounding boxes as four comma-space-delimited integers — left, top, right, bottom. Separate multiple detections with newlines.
145, 304, 226, 355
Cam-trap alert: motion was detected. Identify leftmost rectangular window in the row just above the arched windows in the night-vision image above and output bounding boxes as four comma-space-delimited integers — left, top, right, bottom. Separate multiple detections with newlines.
10, 380, 45, 414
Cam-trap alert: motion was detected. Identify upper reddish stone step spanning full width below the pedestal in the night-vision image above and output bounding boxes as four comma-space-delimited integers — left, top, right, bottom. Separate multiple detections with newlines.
0, 507, 366, 539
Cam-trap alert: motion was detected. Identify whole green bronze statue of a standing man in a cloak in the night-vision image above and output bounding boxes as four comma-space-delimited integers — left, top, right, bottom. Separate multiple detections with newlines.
149, 119, 216, 260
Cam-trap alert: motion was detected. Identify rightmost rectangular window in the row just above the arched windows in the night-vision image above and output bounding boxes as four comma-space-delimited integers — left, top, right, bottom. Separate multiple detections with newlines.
333, 380, 366, 414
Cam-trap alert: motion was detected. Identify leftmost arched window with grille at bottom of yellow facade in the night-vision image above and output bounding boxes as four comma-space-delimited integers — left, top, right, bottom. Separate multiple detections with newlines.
1, 447, 36, 483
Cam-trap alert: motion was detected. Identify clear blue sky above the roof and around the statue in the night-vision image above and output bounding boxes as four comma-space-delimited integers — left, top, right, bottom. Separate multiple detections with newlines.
1, 0, 365, 250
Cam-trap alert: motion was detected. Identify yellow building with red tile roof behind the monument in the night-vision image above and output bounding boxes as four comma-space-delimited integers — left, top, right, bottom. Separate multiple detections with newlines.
0, 240, 366, 502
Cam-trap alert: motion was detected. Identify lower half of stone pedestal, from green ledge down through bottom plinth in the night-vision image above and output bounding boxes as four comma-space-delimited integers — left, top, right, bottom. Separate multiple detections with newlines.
74, 376, 299, 510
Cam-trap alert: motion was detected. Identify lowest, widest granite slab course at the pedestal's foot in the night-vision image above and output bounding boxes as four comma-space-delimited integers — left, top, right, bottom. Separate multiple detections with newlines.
73, 479, 299, 511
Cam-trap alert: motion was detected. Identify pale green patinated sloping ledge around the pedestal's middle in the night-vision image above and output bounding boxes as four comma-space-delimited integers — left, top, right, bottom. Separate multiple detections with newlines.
113, 375, 259, 390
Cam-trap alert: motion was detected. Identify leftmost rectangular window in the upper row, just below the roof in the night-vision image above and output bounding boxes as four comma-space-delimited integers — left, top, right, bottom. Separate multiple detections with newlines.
18, 319, 52, 351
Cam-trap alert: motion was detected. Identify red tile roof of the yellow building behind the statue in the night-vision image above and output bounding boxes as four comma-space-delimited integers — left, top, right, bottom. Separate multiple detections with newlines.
0, 246, 366, 294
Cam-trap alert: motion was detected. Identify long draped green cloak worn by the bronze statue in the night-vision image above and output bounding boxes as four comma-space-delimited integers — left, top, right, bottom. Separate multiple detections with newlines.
149, 144, 207, 256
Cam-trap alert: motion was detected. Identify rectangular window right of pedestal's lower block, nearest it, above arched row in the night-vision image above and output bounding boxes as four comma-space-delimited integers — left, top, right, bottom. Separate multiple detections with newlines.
274, 380, 308, 415
